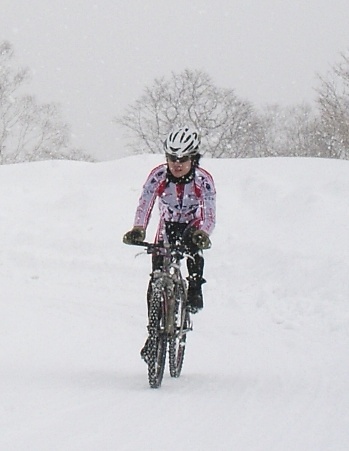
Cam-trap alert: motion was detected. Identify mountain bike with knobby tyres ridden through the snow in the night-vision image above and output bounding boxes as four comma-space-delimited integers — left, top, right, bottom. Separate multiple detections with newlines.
134, 242, 193, 388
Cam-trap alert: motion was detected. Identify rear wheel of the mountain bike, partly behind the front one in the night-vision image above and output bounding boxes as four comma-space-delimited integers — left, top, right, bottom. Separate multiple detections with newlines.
169, 283, 190, 377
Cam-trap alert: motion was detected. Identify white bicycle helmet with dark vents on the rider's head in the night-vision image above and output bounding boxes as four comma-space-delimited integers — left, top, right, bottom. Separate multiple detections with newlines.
164, 127, 201, 158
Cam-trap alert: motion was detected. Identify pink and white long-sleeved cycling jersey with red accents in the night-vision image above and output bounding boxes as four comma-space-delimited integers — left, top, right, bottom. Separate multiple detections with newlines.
134, 164, 216, 241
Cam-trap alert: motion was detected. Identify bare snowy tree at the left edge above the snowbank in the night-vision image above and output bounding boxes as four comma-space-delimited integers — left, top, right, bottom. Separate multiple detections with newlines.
0, 42, 93, 164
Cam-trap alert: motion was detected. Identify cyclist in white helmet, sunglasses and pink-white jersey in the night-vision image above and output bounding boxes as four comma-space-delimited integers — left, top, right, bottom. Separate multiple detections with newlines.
123, 127, 216, 313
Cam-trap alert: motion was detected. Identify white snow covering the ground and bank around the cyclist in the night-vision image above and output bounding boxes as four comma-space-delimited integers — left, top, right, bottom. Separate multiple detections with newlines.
0, 156, 349, 451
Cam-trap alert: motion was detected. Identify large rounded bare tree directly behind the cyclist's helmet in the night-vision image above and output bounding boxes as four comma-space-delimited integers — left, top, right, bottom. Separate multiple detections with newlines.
115, 70, 263, 157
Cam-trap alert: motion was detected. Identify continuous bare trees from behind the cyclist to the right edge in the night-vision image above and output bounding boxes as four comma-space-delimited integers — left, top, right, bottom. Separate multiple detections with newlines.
115, 58, 349, 159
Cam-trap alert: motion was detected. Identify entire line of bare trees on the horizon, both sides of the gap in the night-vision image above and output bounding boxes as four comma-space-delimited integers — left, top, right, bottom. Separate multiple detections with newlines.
0, 41, 349, 164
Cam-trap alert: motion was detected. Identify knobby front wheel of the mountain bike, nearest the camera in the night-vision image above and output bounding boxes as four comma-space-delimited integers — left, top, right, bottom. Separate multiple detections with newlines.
147, 284, 167, 388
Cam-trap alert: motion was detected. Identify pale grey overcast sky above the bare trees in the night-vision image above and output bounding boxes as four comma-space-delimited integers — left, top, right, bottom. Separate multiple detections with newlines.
0, 0, 349, 158
